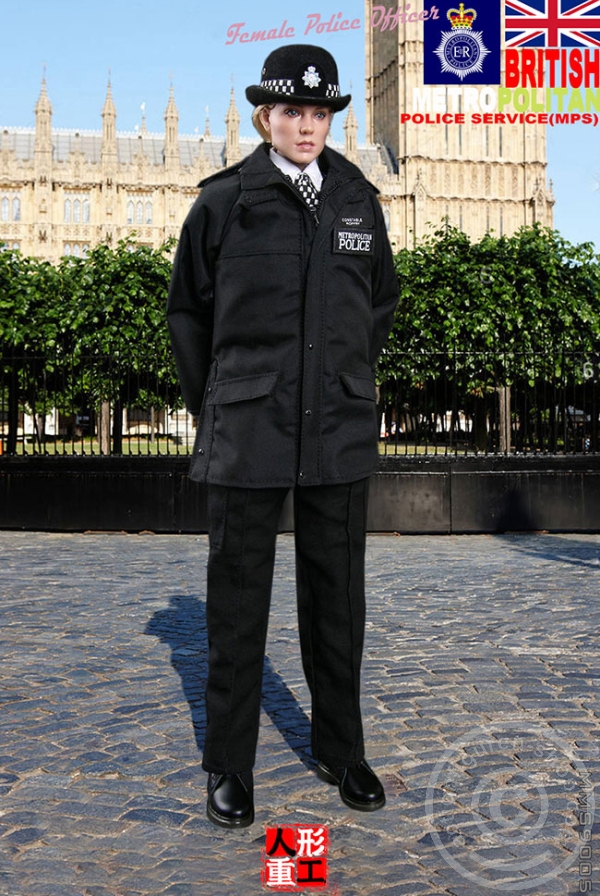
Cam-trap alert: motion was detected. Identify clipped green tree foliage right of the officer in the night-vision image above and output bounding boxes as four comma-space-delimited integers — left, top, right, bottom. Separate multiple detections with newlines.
379, 225, 600, 447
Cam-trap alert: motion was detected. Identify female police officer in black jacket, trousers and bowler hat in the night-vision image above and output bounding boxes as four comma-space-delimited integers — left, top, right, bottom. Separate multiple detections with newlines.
168, 45, 398, 827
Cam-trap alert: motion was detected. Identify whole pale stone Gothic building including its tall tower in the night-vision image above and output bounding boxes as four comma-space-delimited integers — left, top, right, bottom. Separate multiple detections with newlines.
0, 11, 554, 262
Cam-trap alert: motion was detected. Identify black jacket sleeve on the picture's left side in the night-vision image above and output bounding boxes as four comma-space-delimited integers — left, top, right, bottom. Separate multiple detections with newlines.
167, 196, 218, 415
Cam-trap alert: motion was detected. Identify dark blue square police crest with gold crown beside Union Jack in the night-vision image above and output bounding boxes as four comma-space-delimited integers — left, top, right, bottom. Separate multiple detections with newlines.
423, 0, 501, 84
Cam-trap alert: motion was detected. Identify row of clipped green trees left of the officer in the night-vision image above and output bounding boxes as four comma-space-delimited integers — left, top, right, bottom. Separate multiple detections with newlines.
0, 238, 177, 453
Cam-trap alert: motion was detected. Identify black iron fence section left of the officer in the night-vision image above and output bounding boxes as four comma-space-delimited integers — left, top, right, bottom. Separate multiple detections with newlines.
0, 354, 195, 456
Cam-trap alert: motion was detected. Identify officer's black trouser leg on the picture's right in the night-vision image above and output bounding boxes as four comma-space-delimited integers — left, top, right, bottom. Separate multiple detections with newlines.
294, 479, 368, 766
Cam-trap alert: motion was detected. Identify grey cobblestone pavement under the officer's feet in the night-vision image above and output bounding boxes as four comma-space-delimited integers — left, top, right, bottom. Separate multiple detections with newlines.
0, 532, 600, 896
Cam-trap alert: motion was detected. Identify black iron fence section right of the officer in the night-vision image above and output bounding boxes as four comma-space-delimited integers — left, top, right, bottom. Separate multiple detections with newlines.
380, 348, 600, 456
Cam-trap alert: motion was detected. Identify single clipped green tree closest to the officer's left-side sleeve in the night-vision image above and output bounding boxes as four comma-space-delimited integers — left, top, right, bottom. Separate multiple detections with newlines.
54, 238, 177, 453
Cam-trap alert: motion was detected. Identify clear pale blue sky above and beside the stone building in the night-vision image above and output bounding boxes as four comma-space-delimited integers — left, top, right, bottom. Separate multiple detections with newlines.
0, 0, 600, 252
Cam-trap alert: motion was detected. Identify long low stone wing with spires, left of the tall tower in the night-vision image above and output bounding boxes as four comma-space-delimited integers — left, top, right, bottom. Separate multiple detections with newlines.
0, 81, 393, 262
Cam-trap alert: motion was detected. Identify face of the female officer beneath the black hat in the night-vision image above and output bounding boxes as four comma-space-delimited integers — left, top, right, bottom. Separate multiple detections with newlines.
261, 103, 333, 170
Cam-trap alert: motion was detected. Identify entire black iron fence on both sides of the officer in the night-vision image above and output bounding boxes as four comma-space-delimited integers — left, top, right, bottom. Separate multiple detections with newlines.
0, 348, 600, 456
